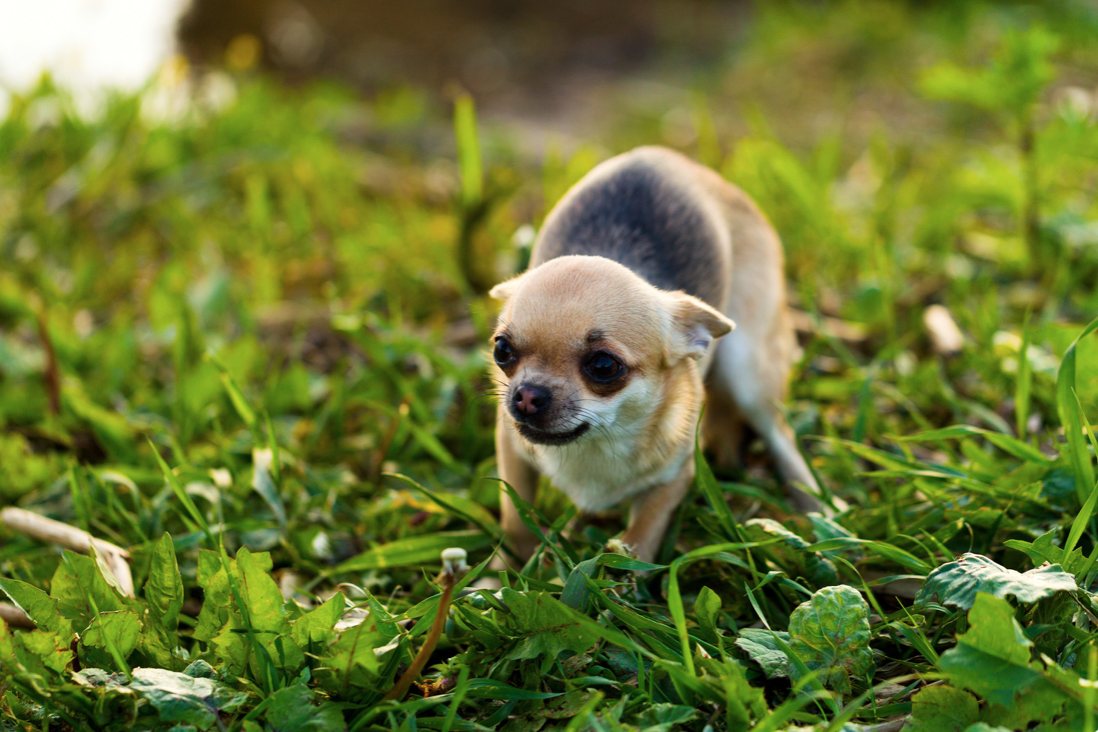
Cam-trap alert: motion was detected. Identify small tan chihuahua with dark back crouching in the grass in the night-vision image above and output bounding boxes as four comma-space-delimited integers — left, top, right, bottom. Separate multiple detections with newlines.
491, 147, 821, 562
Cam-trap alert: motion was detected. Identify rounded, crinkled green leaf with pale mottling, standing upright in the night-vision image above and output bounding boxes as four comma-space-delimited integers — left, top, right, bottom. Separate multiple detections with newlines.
789, 585, 874, 694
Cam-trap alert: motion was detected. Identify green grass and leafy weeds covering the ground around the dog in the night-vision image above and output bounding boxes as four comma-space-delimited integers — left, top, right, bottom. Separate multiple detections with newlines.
0, 3, 1098, 732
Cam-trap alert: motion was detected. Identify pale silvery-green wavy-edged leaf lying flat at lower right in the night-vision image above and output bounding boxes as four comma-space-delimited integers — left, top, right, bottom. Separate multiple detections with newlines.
916, 554, 1078, 610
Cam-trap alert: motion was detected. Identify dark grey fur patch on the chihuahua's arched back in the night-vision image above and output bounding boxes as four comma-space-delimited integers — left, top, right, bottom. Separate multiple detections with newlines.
537, 160, 725, 306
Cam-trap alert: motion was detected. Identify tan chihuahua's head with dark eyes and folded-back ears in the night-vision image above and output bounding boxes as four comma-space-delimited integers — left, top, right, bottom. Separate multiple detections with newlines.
491, 256, 735, 444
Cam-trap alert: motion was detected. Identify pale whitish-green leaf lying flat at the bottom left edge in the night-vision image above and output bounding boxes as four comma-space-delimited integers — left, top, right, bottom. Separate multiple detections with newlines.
130, 668, 247, 730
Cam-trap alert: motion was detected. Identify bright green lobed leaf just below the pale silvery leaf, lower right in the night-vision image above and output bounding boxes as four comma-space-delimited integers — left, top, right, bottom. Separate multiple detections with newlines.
938, 593, 1041, 707
